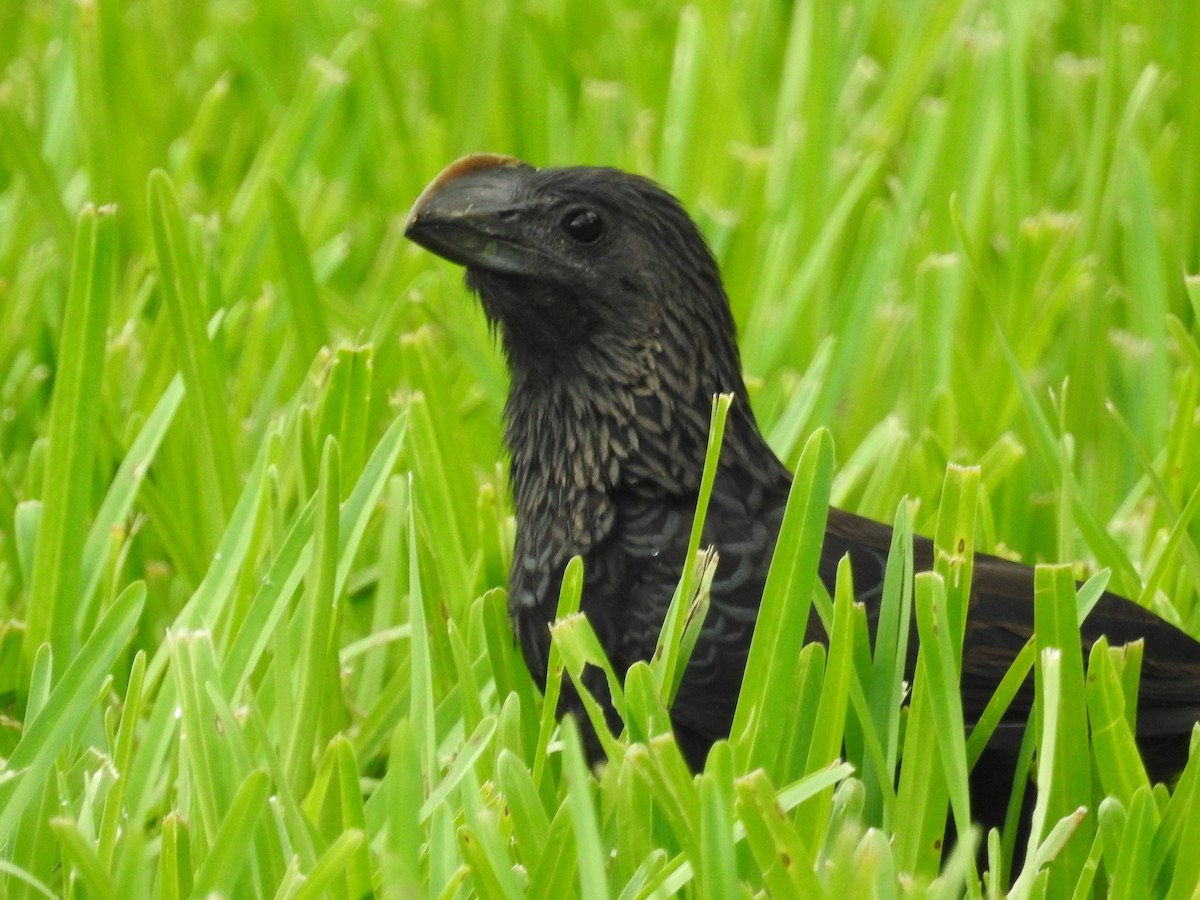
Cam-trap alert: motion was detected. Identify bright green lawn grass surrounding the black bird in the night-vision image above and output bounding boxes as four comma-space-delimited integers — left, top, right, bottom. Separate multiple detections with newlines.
0, 0, 1200, 898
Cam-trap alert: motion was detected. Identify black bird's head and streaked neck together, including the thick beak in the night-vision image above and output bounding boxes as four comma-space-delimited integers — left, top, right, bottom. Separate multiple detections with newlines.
404, 154, 787, 504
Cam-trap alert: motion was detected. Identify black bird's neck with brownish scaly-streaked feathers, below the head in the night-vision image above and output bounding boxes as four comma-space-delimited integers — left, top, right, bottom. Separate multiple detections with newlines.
505, 336, 790, 542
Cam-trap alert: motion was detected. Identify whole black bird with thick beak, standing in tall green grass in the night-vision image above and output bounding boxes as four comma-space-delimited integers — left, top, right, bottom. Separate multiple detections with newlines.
406, 154, 1200, 826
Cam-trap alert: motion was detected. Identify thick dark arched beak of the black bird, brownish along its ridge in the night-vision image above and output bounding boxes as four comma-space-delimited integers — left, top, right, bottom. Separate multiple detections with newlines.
404, 154, 541, 274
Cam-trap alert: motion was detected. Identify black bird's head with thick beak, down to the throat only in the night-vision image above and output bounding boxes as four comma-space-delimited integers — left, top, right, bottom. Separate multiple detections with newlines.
404, 154, 742, 391
